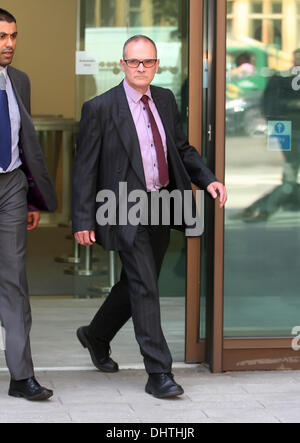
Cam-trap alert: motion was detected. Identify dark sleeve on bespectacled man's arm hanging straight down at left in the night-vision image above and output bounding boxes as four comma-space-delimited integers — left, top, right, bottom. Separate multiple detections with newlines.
72, 102, 101, 233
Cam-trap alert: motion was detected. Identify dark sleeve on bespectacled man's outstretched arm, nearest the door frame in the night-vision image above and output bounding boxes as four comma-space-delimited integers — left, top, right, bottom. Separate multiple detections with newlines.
170, 92, 218, 190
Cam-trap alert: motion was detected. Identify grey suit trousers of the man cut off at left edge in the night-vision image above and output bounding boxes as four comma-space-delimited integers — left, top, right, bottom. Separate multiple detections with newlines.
0, 169, 33, 380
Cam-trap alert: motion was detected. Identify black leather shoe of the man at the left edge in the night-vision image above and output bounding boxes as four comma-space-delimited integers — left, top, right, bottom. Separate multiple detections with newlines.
8, 377, 53, 401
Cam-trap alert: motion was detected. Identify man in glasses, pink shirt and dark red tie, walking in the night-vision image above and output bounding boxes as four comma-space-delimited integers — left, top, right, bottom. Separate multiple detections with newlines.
73, 36, 227, 398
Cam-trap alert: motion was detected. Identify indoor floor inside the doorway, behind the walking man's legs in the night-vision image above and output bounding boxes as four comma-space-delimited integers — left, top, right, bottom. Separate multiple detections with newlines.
0, 297, 185, 368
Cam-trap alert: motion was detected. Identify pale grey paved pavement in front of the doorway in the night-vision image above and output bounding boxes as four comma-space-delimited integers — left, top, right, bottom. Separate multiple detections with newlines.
0, 366, 300, 425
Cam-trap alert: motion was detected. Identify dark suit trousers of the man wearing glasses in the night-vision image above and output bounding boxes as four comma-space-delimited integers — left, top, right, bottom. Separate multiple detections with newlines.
89, 226, 172, 374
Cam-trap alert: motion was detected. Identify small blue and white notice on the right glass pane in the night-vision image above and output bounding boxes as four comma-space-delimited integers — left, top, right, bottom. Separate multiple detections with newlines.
268, 121, 292, 152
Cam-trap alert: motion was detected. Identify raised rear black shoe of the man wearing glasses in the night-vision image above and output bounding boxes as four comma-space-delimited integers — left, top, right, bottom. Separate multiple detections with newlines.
77, 326, 119, 372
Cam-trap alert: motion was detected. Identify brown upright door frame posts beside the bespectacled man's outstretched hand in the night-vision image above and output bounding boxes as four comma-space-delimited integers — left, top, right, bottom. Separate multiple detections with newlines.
186, 0, 226, 372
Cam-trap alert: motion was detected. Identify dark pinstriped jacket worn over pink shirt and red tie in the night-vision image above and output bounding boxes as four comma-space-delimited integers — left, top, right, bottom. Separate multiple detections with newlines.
72, 83, 217, 250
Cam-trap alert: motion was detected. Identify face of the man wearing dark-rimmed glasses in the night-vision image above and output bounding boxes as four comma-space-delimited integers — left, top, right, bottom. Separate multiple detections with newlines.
121, 40, 159, 93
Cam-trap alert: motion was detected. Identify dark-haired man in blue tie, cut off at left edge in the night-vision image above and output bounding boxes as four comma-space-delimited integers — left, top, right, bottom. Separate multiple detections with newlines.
0, 9, 57, 401
